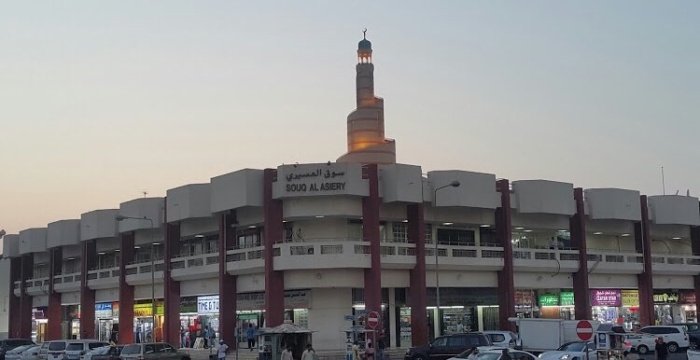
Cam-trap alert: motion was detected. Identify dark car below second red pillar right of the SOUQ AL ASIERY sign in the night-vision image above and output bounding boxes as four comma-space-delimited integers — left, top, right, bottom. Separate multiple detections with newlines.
404, 332, 491, 360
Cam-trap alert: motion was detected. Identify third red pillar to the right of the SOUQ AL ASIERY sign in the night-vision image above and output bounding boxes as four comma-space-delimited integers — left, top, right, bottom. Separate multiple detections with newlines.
496, 179, 515, 331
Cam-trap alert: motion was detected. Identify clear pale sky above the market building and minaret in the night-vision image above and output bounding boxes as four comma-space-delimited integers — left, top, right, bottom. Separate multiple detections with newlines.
0, 0, 700, 233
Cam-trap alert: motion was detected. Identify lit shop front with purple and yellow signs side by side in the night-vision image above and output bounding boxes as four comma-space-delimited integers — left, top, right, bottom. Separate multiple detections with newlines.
590, 289, 640, 330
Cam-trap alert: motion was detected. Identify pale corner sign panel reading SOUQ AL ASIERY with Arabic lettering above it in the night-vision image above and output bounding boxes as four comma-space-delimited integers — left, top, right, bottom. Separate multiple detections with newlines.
272, 163, 369, 198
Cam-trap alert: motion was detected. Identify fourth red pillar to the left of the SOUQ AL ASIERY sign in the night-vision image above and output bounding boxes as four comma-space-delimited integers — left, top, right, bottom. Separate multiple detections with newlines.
118, 232, 134, 344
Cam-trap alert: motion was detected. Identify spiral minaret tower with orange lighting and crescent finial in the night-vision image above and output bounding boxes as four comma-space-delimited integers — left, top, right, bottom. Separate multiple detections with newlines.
338, 29, 396, 164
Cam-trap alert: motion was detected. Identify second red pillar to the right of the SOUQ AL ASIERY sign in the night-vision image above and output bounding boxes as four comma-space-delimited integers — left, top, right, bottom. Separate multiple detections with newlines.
406, 200, 429, 346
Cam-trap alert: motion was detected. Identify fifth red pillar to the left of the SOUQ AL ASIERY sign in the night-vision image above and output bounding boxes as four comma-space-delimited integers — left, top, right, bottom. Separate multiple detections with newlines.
80, 240, 97, 339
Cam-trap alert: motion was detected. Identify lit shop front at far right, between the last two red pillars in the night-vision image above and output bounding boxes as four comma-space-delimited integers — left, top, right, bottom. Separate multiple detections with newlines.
654, 290, 697, 325
